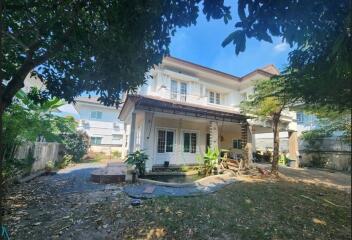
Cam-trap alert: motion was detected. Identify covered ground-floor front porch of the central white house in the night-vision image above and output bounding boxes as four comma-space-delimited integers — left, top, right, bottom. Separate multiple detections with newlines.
126, 96, 300, 171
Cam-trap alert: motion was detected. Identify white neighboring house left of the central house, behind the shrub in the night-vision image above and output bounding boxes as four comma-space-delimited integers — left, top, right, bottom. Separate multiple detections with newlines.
74, 97, 124, 153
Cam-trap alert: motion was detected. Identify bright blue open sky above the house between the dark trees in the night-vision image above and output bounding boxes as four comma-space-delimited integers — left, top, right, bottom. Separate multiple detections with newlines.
170, 0, 290, 76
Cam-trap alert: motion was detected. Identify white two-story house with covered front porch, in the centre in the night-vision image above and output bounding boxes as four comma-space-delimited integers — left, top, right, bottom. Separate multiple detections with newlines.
119, 57, 298, 171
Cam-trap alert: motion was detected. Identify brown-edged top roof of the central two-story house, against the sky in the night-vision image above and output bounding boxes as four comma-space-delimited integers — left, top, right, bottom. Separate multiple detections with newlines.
164, 56, 280, 82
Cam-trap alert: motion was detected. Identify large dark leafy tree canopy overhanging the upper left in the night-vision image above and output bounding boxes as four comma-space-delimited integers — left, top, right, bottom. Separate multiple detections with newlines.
0, 0, 230, 224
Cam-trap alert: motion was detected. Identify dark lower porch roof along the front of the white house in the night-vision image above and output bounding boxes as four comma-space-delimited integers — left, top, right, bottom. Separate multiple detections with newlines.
119, 95, 249, 123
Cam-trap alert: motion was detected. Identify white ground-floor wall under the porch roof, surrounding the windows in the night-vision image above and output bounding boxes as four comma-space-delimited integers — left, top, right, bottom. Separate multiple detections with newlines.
125, 111, 243, 171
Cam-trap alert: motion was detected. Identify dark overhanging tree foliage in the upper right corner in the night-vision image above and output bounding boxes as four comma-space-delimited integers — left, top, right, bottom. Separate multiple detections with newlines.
222, 0, 352, 111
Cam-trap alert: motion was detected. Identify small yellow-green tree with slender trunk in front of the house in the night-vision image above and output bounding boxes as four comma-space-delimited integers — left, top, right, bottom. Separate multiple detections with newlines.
241, 76, 296, 174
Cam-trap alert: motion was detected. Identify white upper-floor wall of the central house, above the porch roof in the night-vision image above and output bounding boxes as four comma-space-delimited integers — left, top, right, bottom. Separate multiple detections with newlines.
137, 62, 296, 124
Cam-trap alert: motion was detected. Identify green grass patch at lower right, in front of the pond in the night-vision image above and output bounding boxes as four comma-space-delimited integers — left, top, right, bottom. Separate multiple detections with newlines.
119, 181, 351, 239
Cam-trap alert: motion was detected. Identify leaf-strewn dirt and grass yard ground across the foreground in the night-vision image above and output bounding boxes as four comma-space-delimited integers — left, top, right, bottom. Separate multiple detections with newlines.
5, 164, 351, 240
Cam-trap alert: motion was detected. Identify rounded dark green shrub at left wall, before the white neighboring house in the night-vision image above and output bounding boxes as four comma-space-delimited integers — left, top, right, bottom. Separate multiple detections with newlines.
62, 131, 89, 162
